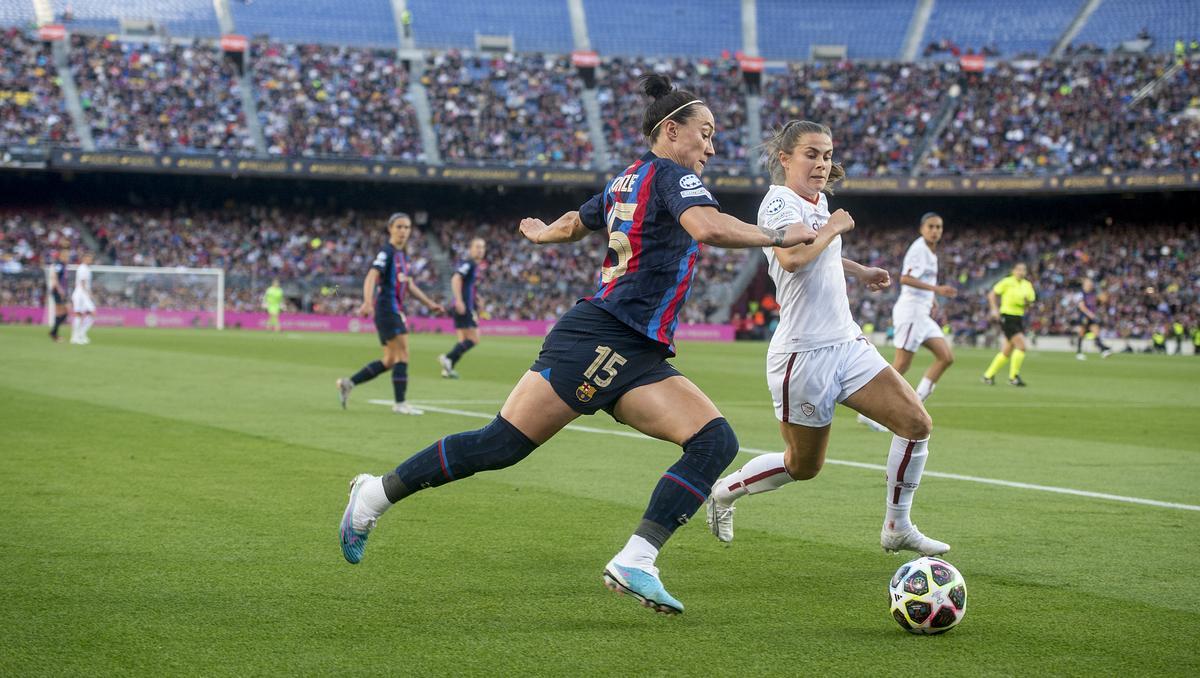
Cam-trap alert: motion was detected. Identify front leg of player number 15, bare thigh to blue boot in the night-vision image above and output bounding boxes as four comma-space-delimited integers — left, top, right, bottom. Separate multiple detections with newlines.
604, 376, 738, 614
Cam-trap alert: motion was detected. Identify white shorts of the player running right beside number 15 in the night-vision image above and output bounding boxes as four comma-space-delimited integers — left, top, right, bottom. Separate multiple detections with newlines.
767, 337, 888, 428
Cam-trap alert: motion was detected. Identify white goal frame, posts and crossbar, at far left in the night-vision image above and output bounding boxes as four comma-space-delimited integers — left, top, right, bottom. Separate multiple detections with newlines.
46, 264, 224, 330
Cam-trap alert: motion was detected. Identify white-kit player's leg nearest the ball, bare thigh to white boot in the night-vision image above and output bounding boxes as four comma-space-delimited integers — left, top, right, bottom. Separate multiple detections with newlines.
842, 368, 950, 556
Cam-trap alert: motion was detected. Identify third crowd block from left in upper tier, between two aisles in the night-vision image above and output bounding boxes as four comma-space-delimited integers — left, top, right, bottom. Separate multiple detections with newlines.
252, 42, 424, 162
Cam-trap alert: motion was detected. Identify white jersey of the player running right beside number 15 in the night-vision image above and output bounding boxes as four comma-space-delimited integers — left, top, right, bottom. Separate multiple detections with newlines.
758, 186, 863, 353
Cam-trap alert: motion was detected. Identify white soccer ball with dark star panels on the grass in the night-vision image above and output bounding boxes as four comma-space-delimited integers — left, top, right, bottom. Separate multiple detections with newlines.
888, 557, 967, 635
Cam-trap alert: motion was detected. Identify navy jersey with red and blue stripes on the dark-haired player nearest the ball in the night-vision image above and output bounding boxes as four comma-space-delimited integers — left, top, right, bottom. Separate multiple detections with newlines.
580, 152, 720, 347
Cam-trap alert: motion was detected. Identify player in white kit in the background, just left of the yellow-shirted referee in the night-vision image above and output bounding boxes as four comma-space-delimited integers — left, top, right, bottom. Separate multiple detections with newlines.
858, 212, 959, 431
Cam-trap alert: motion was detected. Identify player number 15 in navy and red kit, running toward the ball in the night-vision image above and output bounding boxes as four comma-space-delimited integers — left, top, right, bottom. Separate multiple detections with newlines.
341, 74, 816, 614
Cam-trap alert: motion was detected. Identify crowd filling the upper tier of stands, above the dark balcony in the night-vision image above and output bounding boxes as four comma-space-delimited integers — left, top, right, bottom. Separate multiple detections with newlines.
0, 24, 1200, 176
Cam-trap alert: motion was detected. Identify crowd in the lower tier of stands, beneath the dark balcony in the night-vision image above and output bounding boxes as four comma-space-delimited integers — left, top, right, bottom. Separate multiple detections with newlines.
0, 198, 1200, 343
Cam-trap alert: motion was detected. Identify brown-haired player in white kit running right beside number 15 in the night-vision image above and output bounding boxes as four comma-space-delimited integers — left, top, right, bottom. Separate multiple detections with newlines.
707, 120, 950, 556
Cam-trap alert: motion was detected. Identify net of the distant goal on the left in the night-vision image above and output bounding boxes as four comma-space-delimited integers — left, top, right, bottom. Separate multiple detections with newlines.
46, 264, 224, 330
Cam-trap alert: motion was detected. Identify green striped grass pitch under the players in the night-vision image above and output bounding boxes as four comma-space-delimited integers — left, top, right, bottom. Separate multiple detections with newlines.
0, 326, 1200, 676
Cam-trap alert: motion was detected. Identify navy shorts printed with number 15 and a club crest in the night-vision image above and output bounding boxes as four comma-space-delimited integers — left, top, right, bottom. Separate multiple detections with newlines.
529, 301, 680, 414
